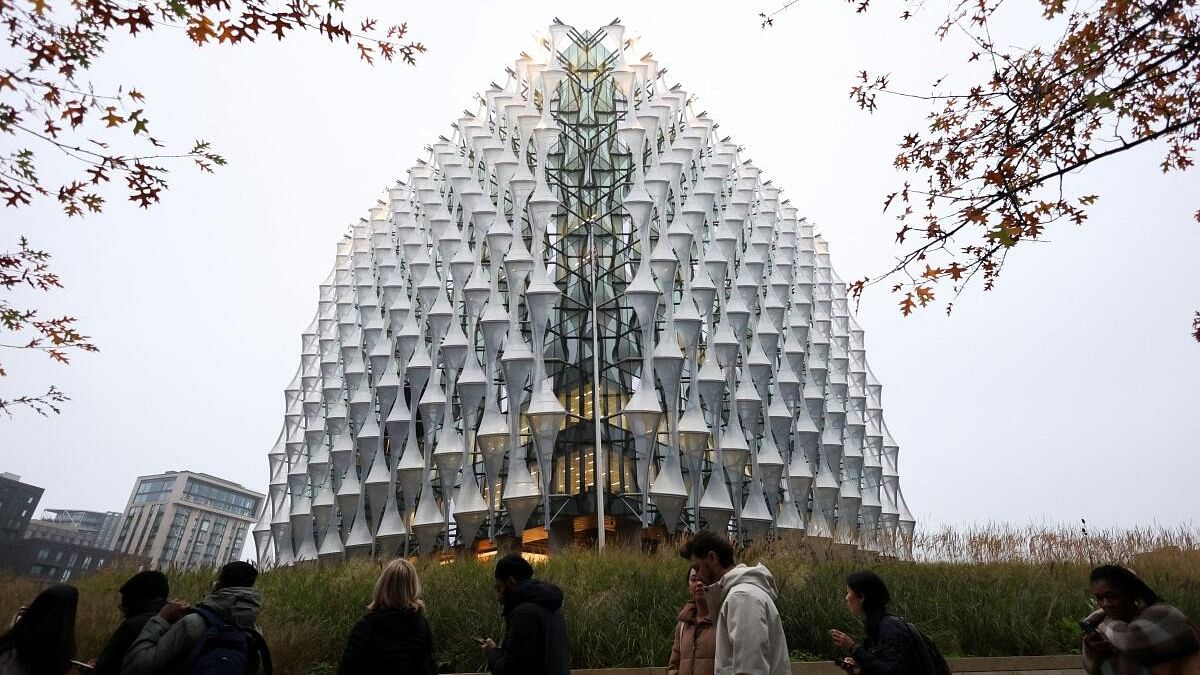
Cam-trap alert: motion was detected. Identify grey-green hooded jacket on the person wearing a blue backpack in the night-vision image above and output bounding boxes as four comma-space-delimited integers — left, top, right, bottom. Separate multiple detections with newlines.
121, 587, 263, 675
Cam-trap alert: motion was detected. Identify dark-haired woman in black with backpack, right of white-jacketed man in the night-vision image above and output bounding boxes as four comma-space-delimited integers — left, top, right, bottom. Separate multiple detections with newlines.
829, 572, 926, 675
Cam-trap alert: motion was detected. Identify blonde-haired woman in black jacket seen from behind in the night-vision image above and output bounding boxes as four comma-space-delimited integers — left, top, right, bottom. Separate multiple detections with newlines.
337, 557, 437, 675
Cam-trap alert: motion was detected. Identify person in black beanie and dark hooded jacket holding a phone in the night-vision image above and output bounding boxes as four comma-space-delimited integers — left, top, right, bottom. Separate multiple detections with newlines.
480, 554, 570, 675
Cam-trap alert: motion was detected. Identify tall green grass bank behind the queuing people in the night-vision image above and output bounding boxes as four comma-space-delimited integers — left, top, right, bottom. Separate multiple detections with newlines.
0, 550, 1200, 675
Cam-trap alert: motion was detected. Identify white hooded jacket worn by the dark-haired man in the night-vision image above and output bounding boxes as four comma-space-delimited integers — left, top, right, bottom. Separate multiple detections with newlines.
704, 563, 792, 675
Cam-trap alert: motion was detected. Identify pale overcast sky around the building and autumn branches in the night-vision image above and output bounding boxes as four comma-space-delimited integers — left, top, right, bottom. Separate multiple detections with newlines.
0, 0, 1200, 526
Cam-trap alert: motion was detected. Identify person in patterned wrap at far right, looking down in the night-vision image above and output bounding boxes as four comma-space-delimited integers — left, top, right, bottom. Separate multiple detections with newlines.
1080, 565, 1200, 675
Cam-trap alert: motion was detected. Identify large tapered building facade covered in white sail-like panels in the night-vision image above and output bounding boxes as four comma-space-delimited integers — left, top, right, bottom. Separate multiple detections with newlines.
254, 24, 913, 565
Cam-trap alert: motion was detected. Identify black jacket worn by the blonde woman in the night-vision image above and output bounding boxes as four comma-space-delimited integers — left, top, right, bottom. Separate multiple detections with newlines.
337, 608, 437, 675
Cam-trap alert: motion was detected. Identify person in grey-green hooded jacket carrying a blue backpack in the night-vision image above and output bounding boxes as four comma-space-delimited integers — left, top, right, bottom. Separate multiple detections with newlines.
122, 560, 271, 675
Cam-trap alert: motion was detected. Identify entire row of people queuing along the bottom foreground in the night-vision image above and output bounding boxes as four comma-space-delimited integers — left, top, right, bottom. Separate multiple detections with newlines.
0, 532, 1200, 675
